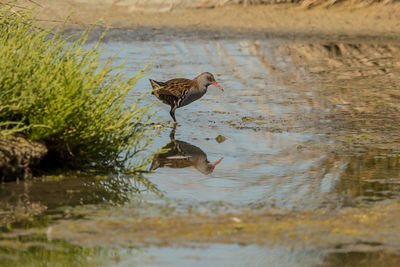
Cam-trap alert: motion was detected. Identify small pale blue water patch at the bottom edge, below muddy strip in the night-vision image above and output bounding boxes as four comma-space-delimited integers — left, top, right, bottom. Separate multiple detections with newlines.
128, 244, 322, 266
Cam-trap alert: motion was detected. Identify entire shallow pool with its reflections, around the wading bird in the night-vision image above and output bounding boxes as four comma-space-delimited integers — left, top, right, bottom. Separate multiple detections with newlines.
0, 32, 400, 266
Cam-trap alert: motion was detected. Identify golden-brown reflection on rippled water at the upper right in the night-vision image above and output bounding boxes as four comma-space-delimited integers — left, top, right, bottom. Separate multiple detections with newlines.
271, 42, 400, 149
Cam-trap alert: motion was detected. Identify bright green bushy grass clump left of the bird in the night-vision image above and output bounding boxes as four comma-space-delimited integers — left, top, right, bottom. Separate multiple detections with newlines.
0, 6, 157, 170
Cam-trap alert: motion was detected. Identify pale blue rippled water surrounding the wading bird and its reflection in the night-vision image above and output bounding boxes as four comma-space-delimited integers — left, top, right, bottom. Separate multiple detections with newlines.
107, 40, 338, 207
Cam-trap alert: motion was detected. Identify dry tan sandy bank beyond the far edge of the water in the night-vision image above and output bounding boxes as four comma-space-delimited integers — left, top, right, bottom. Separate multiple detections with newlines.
31, 0, 400, 39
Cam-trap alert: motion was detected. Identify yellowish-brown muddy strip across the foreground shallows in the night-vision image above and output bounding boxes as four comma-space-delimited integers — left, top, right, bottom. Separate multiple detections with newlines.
21, 202, 400, 253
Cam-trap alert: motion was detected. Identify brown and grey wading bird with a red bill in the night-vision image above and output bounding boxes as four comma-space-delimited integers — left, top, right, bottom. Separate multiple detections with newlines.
149, 72, 224, 124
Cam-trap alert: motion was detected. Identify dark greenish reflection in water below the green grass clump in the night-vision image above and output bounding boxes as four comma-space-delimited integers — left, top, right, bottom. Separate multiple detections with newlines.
0, 173, 162, 232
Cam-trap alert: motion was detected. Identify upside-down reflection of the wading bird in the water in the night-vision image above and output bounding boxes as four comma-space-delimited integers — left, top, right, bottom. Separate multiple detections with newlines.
150, 127, 222, 174
